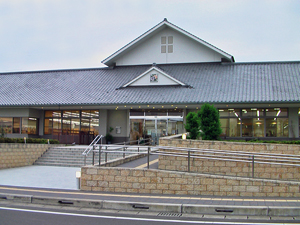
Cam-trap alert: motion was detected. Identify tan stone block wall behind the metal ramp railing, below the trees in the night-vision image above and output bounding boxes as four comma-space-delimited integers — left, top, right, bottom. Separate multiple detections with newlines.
159, 138, 300, 181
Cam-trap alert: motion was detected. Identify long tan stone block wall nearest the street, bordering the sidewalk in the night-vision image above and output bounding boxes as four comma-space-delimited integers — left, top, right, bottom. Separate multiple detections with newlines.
81, 166, 300, 197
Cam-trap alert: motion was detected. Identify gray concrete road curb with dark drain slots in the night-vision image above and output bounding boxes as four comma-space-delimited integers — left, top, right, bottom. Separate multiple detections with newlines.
0, 193, 300, 216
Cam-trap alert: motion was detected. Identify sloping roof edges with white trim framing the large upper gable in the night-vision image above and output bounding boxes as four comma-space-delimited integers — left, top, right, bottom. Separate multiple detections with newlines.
102, 18, 234, 66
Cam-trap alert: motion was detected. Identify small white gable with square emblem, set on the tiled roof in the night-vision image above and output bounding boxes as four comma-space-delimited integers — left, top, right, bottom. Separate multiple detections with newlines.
123, 66, 187, 88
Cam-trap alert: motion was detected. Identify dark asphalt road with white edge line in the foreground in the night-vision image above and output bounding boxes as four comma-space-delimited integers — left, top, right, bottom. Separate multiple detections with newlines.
0, 203, 293, 225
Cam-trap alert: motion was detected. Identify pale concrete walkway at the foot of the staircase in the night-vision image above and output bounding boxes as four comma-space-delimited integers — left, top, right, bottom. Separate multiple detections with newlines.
0, 166, 81, 190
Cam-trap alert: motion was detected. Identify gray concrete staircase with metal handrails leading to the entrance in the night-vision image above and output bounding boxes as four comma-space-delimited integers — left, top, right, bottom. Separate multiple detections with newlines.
34, 146, 123, 167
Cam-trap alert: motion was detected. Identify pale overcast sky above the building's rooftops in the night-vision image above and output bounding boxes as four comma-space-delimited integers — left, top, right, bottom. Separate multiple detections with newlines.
0, 0, 300, 72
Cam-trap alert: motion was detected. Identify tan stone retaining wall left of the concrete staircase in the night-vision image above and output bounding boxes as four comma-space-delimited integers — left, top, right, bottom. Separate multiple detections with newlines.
0, 143, 62, 169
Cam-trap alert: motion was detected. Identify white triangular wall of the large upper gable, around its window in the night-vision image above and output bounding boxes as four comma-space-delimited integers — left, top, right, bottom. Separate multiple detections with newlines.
116, 27, 222, 66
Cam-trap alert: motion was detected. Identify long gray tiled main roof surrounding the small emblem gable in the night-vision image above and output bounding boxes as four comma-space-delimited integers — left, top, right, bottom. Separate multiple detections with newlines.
0, 62, 300, 106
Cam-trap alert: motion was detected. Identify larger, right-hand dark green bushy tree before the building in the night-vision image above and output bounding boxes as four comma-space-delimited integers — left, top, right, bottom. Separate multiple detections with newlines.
197, 103, 222, 140
